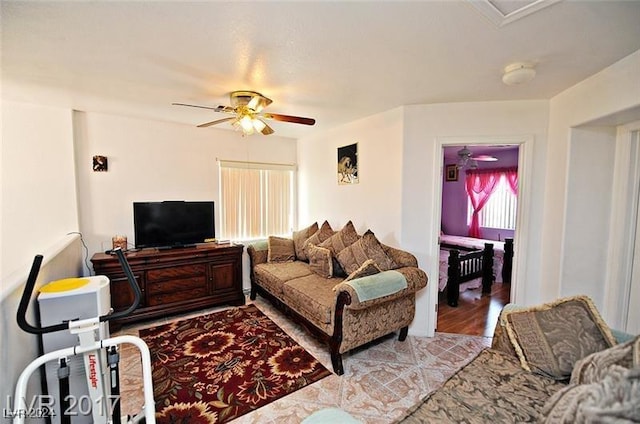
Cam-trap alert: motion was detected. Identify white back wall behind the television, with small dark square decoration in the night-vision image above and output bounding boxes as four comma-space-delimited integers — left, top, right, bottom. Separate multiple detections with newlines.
73, 112, 296, 288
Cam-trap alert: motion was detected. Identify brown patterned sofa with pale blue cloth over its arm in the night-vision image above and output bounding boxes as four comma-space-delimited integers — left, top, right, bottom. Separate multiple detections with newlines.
247, 221, 427, 375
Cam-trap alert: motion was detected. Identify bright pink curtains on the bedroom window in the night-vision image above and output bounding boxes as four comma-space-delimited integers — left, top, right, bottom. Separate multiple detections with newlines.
465, 168, 518, 238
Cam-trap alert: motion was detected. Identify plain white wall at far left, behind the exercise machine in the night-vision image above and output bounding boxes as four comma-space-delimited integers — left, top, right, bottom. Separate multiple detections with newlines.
0, 100, 78, 288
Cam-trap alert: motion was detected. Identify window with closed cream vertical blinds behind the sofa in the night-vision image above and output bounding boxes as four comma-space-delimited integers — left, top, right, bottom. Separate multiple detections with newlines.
220, 161, 295, 240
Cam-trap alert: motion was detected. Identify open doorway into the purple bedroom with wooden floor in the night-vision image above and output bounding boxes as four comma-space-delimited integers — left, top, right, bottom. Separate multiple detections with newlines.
436, 144, 520, 337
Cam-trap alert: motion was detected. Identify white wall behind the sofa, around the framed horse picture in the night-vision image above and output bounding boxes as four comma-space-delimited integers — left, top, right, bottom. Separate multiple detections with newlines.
298, 108, 403, 240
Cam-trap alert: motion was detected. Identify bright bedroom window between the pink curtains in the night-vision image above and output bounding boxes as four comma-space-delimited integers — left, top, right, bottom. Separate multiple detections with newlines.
467, 175, 518, 230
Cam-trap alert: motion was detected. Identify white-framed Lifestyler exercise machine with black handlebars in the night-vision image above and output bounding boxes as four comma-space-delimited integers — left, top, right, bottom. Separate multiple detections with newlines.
12, 249, 155, 424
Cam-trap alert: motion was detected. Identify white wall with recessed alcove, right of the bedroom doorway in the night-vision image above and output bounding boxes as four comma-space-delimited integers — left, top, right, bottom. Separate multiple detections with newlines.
540, 51, 640, 325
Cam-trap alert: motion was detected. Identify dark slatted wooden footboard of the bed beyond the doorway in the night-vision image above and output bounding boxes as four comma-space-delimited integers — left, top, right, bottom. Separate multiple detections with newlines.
438, 243, 494, 307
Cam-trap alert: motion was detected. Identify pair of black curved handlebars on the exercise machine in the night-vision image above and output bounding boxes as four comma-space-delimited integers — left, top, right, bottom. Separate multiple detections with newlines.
17, 248, 142, 334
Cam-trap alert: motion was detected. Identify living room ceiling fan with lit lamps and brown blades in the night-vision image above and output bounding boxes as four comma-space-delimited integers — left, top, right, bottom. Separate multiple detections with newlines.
172, 91, 316, 135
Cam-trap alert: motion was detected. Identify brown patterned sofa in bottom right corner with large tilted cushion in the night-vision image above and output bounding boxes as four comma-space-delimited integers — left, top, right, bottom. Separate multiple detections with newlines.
395, 296, 640, 424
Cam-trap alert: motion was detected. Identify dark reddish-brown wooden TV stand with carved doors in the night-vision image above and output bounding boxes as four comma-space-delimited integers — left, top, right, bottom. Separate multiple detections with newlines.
91, 243, 245, 330
